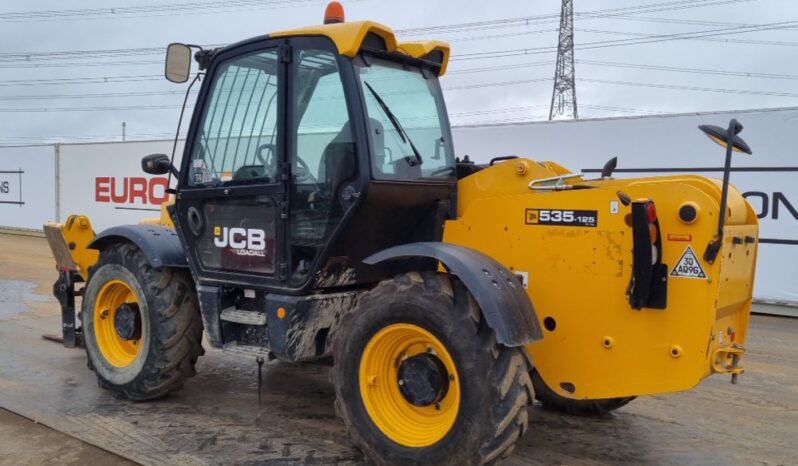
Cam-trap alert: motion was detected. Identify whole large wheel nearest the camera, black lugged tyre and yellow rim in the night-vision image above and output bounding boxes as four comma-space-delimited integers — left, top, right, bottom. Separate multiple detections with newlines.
332, 272, 532, 465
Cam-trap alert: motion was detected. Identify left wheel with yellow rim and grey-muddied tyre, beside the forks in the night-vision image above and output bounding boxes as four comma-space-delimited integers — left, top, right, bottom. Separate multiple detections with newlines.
81, 243, 204, 400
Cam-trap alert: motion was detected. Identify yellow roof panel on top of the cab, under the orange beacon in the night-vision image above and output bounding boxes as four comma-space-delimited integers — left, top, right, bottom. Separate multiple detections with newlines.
269, 21, 449, 76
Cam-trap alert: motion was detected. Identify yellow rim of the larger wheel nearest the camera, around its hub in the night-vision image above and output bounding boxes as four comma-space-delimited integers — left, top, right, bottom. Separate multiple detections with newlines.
359, 323, 460, 448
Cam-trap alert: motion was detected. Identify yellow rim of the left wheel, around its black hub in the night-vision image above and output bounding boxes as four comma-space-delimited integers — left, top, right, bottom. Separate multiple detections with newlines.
94, 280, 141, 367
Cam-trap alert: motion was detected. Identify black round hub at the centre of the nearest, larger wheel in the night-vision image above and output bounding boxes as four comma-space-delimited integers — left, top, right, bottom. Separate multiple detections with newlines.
397, 353, 449, 406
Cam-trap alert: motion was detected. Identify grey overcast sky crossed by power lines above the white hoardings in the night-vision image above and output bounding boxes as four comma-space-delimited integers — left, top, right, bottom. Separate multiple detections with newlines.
0, 0, 798, 144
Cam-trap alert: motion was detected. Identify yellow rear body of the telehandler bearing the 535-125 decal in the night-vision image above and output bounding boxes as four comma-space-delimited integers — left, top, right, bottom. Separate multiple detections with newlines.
444, 159, 758, 399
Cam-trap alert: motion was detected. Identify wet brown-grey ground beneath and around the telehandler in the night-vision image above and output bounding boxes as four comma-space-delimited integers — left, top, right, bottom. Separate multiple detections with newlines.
0, 235, 798, 465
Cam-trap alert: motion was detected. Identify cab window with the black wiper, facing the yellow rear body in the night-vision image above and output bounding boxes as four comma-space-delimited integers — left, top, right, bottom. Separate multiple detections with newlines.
357, 57, 455, 180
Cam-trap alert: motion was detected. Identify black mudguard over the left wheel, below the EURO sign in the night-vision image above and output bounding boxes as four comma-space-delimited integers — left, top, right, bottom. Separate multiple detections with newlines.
88, 225, 188, 269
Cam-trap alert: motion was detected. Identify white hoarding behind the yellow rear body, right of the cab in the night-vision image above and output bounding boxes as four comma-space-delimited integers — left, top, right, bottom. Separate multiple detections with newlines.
453, 107, 798, 306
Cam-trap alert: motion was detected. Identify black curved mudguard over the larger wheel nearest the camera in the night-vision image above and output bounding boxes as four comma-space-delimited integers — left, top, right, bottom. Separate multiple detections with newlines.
363, 242, 543, 346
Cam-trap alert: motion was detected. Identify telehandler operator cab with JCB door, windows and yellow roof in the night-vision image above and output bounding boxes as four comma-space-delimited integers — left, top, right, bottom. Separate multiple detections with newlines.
159, 9, 456, 293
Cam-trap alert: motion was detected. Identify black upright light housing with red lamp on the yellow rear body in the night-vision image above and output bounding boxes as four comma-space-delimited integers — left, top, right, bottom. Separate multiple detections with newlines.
627, 199, 668, 309
